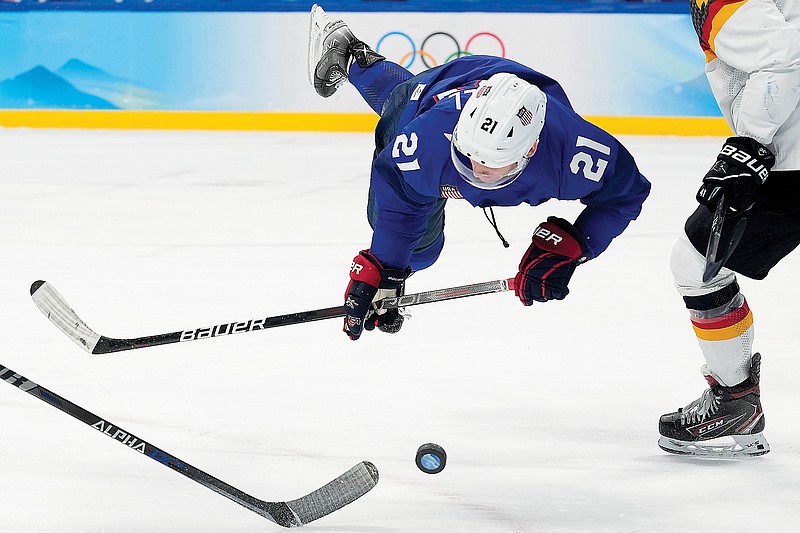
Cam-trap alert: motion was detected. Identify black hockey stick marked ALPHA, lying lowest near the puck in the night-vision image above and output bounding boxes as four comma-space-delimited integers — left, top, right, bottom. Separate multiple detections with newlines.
0, 365, 378, 527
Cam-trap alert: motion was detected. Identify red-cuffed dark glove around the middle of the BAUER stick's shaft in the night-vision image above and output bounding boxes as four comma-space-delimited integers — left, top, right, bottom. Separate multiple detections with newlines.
343, 250, 411, 341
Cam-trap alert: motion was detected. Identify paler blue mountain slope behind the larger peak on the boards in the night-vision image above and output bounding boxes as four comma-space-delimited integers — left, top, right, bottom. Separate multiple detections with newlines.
56, 58, 171, 109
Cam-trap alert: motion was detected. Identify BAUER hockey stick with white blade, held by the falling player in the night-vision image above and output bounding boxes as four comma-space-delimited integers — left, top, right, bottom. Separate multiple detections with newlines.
31, 278, 514, 354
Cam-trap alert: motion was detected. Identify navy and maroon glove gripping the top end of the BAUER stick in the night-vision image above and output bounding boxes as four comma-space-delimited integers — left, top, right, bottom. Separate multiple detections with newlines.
514, 217, 590, 305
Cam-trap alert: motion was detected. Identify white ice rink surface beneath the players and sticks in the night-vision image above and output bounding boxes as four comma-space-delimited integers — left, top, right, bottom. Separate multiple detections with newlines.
0, 129, 800, 533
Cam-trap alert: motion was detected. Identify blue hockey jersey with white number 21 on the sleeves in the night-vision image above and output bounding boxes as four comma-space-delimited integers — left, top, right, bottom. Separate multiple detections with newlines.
370, 56, 650, 268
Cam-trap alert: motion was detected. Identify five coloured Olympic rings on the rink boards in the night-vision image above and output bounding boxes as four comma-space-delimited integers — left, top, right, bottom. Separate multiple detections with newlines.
375, 31, 506, 68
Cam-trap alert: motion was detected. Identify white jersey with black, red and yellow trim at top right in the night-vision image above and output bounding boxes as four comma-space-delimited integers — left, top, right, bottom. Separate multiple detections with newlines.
690, 0, 800, 170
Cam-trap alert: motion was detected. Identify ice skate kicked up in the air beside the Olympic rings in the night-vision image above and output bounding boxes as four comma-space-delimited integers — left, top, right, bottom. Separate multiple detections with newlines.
308, 4, 386, 98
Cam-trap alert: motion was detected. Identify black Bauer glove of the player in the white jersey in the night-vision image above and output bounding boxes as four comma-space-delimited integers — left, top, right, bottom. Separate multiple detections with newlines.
697, 137, 775, 213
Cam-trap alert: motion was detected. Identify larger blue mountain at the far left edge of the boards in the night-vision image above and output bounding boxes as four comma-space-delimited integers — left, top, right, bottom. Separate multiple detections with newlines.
0, 65, 117, 109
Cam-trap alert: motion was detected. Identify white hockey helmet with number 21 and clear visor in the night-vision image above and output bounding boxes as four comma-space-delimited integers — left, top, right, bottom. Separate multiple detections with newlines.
450, 72, 547, 189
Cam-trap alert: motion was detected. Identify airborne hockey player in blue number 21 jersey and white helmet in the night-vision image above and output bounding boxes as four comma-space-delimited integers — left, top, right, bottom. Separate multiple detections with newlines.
308, 5, 650, 340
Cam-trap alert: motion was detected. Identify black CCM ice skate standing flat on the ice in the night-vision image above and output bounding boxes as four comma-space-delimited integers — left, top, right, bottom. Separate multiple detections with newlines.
658, 354, 769, 457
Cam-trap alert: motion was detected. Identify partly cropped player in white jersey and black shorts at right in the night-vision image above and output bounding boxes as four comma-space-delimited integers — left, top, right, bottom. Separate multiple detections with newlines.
659, 0, 800, 456
